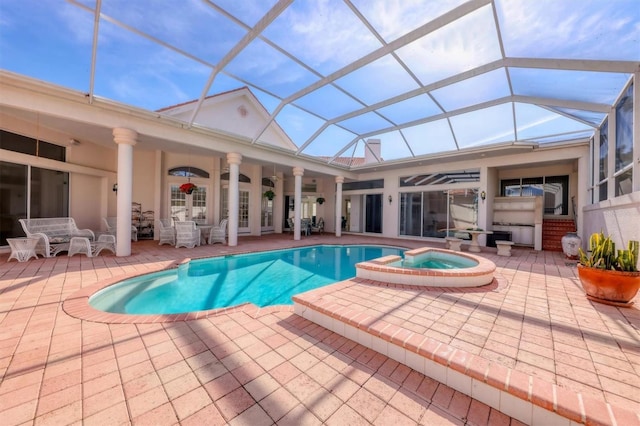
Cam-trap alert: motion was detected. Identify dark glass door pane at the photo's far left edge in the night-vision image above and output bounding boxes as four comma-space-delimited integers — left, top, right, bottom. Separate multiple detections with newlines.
0, 161, 27, 246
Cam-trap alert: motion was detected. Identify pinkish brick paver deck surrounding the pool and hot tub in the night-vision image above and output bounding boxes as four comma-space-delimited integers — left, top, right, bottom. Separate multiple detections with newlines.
0, 234, 640, 425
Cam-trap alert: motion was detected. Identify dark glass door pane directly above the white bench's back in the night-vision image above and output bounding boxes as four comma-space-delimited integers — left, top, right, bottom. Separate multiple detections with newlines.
30, 167, 69, 218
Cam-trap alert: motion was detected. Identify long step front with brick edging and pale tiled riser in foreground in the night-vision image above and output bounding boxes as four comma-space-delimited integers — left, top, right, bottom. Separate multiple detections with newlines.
293, 292, 637, 426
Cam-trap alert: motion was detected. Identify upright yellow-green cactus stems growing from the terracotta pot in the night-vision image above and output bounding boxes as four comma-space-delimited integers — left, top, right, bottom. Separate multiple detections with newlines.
578, 232, 640, 272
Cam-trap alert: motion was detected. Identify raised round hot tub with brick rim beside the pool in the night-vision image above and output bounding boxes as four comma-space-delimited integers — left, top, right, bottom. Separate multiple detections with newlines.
356, 247, 496, 287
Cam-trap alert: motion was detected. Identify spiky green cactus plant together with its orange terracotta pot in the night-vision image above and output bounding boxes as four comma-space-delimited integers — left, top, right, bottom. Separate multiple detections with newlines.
578, 232, 640, 306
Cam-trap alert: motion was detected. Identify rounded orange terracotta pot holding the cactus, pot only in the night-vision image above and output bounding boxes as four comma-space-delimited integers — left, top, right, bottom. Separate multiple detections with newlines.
578, 265, 640, 305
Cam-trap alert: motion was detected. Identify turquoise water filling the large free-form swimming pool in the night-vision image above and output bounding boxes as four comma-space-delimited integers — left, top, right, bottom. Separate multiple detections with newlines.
89, 245, 404, 314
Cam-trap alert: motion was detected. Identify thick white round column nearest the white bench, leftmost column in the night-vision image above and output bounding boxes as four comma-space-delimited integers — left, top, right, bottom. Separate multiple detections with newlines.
113, 128, 138, 256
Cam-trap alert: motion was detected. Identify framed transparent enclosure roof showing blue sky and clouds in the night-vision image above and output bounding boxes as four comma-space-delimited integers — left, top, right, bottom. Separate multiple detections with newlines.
0, 0, 640, 165
